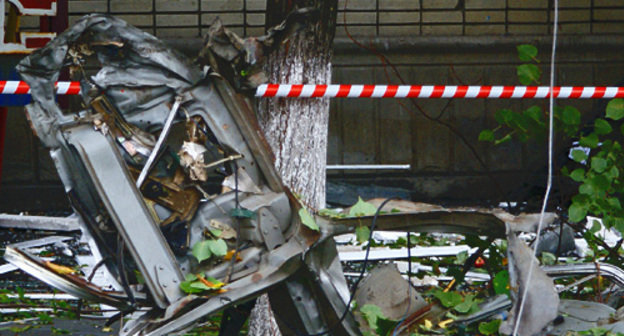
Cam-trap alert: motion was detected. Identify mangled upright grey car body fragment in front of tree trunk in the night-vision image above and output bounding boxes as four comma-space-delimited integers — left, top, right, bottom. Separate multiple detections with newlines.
6, 15, 358, 335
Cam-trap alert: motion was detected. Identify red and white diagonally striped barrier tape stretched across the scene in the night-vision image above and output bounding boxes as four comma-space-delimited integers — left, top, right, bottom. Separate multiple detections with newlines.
0, 81, 624, 99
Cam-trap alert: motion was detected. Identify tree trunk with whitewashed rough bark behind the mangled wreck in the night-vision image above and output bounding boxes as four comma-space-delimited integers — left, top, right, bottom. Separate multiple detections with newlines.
249, 0, 337, 336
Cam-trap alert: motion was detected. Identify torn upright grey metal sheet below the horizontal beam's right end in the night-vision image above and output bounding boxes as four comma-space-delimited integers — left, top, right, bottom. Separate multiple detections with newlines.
499, 230, 559, 336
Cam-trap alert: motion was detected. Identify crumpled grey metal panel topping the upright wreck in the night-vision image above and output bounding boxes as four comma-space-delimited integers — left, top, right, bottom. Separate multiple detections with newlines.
17, 14, 203, 147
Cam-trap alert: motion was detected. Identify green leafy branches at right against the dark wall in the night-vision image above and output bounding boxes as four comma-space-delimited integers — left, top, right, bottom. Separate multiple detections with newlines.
479, 45, 624, 239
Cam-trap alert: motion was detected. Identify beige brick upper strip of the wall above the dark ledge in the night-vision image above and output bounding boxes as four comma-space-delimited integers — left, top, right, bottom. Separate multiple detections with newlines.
12, 0, 624, 38
